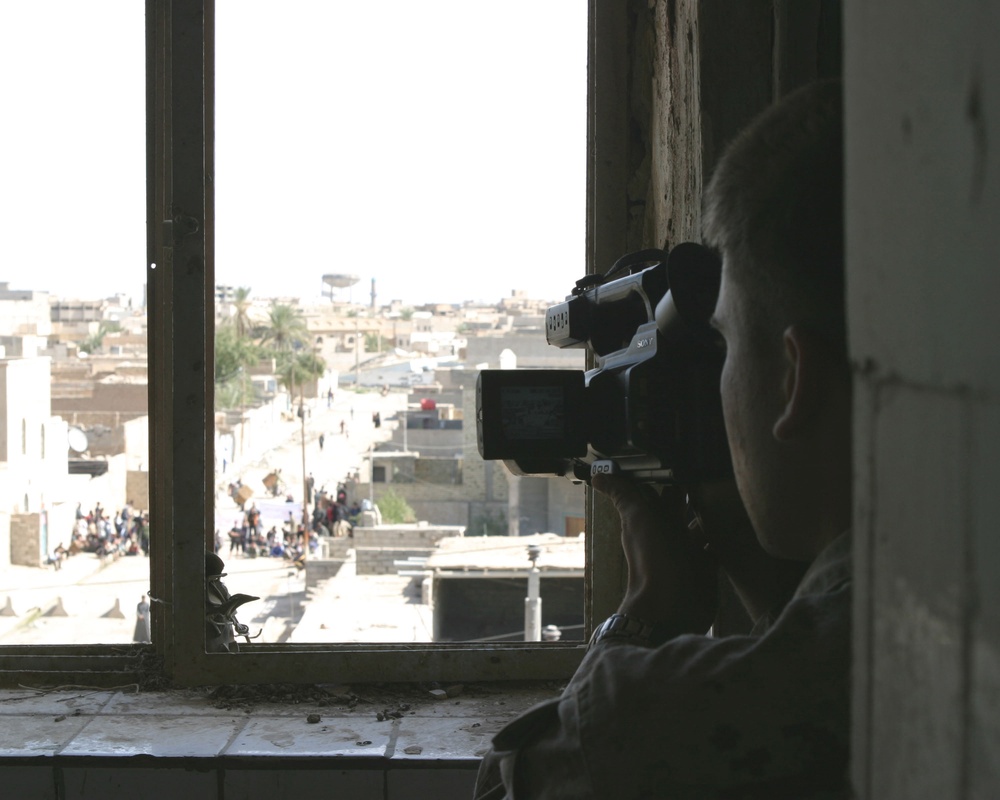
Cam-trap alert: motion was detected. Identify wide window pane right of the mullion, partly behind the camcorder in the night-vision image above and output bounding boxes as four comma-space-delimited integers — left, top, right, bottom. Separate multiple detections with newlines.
214, 0, 587, 642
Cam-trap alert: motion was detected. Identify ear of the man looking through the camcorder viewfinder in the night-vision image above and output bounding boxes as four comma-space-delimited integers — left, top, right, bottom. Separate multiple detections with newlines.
773, 325, 825, 442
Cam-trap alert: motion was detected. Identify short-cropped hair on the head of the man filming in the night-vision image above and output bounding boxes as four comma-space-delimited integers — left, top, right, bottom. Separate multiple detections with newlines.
704, 81, 846, 351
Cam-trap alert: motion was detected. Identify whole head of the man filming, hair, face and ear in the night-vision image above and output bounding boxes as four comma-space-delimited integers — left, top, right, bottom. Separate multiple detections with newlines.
704, 82, 851, 560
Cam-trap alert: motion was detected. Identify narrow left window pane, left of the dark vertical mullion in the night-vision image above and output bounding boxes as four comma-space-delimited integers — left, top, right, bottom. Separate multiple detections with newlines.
0, 0, 149, 645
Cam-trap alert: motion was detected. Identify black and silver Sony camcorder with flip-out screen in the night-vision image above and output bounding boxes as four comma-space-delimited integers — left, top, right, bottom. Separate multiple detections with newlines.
476, 242, 733, 486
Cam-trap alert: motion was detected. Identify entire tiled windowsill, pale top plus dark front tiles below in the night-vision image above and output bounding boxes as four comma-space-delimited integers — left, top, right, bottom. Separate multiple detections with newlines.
0, 685, 558, 800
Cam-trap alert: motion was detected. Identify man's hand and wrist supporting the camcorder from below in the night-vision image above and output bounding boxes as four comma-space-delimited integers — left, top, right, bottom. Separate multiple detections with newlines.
591, 475, 718, 634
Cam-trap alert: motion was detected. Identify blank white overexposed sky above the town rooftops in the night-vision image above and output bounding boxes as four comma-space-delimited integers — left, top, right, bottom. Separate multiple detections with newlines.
0, 0, 587, 303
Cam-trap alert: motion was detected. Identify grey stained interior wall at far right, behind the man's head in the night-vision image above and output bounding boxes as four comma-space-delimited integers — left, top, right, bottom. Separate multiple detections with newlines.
844, 0, 1000, 800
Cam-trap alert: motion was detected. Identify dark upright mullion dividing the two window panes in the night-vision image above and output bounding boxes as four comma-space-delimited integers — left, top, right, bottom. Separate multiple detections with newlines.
148, 0, 214, 683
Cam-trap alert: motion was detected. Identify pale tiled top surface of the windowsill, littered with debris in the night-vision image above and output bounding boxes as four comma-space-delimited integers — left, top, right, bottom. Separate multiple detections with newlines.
0, 683, 559, 770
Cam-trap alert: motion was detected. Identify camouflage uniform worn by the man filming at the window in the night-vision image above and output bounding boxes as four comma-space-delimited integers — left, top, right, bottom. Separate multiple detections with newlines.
476, 534, 851, 800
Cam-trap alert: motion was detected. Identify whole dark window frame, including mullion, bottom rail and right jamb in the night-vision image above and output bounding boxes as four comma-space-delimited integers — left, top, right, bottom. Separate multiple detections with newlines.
0, 0, 628, 686
